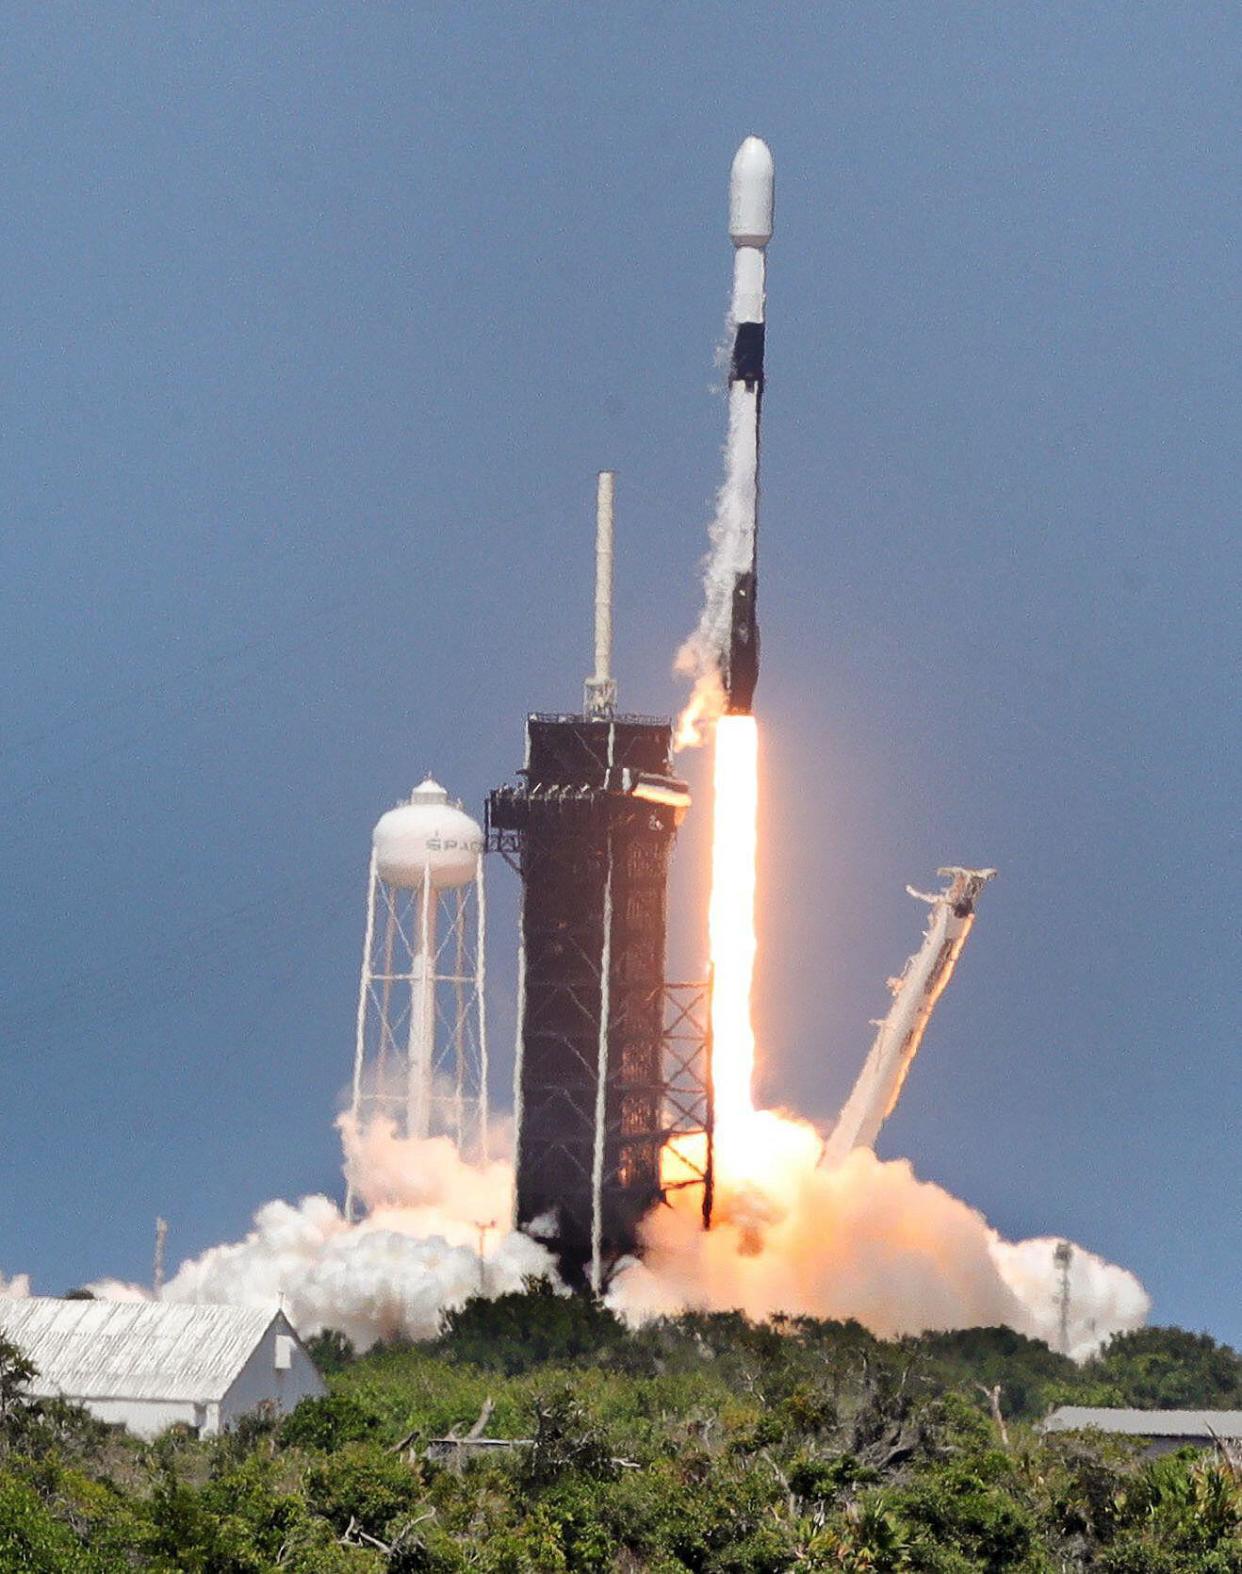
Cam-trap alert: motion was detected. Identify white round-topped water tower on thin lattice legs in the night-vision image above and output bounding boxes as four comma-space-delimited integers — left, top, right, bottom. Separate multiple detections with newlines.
345, 776, 488, 1217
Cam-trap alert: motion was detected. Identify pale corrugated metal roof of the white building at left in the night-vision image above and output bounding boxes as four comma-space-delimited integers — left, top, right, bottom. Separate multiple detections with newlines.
0, 1295, 279, 1402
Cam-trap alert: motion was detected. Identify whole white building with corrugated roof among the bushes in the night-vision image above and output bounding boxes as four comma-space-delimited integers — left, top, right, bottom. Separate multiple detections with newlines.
0, 1295, 327, 1437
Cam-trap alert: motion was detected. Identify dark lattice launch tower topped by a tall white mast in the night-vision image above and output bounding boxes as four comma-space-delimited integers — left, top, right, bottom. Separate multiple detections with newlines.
488, 472, 712, 1291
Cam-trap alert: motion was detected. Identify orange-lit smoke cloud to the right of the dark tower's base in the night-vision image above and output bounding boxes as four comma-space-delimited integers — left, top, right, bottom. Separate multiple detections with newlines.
612, 1111, 1151, 1358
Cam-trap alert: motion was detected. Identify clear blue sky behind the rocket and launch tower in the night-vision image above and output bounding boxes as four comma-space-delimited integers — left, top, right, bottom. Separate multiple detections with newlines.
0, 0, 1242, 1341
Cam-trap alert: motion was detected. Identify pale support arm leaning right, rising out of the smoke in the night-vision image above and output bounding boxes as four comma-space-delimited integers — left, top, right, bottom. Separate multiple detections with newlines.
820, 867, 996, 1169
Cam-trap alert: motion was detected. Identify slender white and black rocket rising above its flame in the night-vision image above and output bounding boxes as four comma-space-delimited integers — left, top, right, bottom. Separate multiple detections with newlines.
721, 137, 776, 715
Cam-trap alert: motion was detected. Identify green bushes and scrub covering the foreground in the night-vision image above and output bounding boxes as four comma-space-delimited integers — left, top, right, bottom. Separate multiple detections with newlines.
0, 1283, 1242, 1574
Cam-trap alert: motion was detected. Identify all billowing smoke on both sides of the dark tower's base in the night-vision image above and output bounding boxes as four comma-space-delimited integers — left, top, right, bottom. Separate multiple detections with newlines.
0, 1111, 1149, 1358
